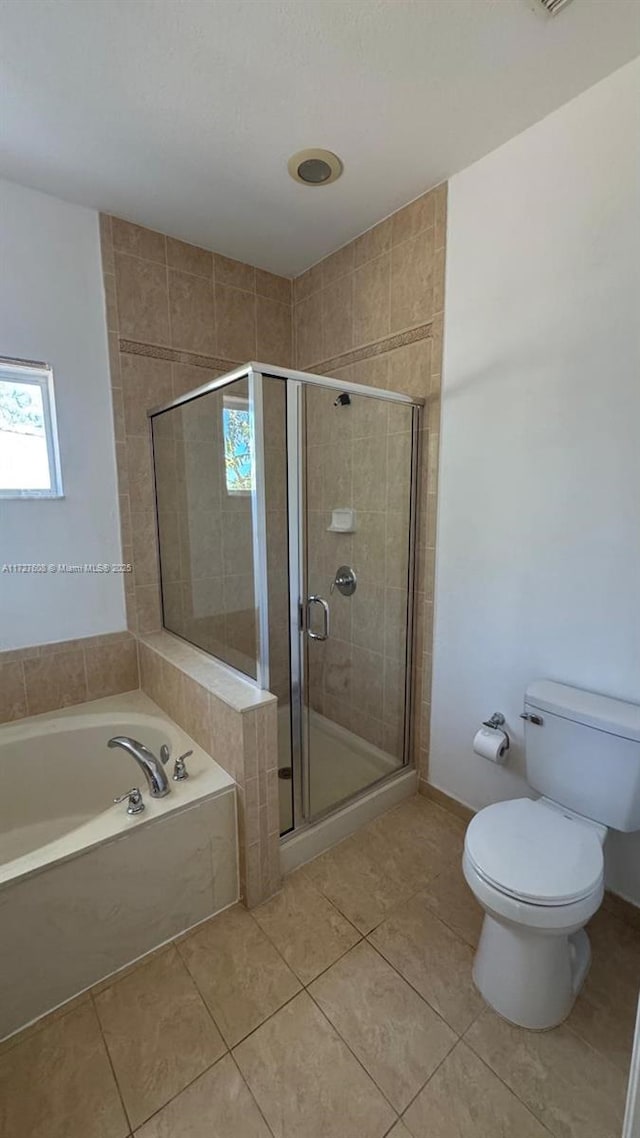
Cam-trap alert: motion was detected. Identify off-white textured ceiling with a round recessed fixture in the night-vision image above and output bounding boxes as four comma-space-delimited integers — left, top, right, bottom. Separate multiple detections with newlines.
0, 0, 640, 274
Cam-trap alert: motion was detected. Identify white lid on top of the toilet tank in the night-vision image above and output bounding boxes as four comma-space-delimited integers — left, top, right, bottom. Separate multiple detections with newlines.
525, 679, 640, 742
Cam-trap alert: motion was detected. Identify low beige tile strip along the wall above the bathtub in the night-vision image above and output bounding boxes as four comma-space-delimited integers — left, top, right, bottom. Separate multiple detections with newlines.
0, 632, 139, 723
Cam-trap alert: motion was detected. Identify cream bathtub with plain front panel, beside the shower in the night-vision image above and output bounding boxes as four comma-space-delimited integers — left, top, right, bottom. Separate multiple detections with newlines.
0, 692, 238, 1039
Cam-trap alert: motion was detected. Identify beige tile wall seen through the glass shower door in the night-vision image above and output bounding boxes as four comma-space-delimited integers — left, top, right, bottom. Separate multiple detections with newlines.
306, 386, 411, 760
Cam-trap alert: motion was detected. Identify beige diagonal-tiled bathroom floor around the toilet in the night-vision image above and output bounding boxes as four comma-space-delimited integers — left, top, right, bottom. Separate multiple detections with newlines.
0, 798, 640, 1138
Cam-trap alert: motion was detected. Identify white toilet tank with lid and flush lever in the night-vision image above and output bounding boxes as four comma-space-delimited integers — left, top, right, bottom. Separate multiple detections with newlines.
525, 679, 640, 832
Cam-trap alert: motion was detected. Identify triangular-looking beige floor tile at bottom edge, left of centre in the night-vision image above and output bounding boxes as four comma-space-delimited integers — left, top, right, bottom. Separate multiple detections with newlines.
137, 1055, 271, 1138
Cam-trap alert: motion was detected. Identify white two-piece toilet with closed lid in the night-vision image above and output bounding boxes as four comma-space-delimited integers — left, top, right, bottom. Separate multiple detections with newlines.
462, 681, 640, 1030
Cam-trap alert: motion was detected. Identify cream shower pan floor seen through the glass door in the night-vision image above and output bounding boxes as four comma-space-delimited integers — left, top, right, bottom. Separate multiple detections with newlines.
278, 707, 402, 828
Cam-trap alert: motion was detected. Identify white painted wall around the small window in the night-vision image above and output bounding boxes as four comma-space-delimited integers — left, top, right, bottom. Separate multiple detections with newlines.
0, 181, 125, 650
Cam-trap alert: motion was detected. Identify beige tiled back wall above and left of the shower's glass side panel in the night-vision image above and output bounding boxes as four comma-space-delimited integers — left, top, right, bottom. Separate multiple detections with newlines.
100, 215, 293, 633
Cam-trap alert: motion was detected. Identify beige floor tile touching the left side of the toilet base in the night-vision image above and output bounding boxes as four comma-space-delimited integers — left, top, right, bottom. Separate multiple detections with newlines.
370, 893, 484, 1034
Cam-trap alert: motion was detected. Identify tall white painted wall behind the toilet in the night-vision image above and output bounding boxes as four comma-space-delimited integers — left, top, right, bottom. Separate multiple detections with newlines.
429, 60, 640, 904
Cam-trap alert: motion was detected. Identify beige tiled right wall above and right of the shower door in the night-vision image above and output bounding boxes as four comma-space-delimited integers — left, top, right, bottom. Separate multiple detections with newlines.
294, 184, 446, 780
